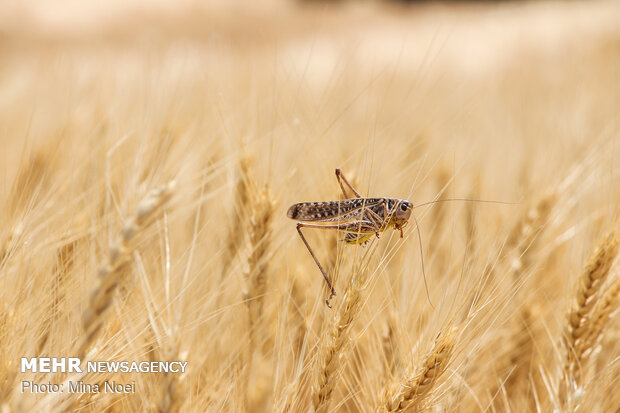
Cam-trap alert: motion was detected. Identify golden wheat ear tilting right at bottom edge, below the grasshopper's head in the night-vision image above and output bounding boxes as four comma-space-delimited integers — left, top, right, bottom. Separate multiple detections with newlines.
378, 326, 457, 412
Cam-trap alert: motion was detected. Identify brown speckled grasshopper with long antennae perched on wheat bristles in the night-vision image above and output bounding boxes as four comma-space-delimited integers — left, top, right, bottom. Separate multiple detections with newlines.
286, 169, 417, 307
